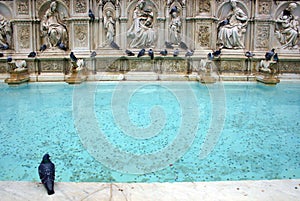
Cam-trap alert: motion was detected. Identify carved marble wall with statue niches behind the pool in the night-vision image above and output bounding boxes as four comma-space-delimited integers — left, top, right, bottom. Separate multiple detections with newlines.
0, 0, 300, 74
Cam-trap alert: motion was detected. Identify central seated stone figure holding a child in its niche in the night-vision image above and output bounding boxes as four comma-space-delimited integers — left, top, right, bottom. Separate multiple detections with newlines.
127, 0, 156, 48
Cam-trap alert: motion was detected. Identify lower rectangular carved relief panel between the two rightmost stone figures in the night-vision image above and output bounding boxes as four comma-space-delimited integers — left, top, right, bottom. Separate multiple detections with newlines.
255, 24, 270, 48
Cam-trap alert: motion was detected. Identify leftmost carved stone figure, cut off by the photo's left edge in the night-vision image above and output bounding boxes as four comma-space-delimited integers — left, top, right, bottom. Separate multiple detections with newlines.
0, 15, 12, 50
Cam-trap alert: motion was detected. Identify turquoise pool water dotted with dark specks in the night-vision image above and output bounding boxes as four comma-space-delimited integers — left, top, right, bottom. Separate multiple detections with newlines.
0, 82, 300, 182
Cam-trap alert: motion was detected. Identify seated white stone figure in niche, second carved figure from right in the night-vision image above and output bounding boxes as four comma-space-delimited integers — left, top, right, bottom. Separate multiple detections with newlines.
218, 0, 248, 49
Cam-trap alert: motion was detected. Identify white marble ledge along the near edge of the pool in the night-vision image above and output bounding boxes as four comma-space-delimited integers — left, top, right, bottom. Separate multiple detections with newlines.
0, 179, 300, 201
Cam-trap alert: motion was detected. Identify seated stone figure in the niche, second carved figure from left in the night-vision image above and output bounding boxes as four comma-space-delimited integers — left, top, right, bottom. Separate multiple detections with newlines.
42, 1, 68, 47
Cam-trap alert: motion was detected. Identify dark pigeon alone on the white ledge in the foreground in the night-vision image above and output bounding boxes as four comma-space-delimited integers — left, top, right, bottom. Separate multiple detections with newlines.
38, 154, 55, 195
